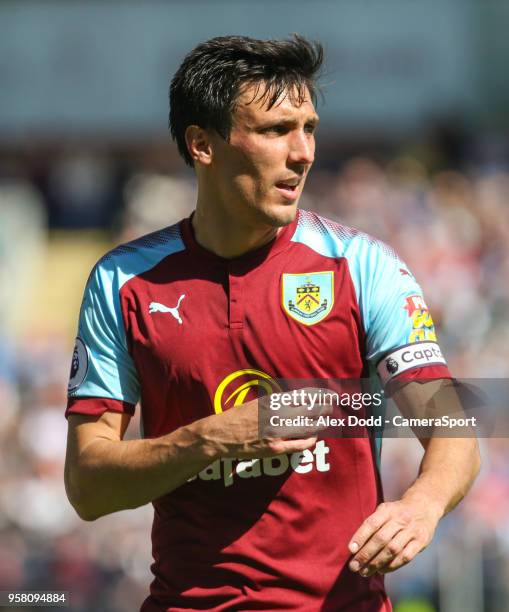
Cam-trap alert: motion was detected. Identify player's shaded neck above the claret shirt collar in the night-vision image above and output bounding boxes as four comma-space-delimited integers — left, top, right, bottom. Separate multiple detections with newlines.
192, 195, 279, 259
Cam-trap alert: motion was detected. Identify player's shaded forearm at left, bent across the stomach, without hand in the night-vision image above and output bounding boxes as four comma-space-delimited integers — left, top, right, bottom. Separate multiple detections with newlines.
66, 421, 216, 520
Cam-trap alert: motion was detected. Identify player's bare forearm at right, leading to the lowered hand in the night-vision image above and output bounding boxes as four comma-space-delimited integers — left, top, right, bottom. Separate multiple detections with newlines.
403, 437, 480, 518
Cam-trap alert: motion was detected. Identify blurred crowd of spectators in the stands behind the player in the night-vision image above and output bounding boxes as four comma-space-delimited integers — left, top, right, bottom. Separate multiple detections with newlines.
0, 142, 509, 612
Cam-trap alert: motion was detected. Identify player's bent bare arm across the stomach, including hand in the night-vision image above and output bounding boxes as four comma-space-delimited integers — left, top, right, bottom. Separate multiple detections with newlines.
65, 392, 322, 520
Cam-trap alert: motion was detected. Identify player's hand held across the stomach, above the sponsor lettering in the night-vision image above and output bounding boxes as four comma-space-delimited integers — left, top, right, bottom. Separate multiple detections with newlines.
200, 388, 332, 459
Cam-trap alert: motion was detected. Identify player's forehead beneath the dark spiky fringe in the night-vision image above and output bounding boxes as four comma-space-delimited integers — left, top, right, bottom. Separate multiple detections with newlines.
233, 83, 318, 125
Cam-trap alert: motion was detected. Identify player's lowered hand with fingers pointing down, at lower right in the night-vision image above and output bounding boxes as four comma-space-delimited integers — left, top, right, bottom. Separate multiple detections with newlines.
348, 498, 441, 578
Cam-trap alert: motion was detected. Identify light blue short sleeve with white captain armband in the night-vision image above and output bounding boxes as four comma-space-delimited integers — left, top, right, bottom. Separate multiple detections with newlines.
366, 244, 450, 384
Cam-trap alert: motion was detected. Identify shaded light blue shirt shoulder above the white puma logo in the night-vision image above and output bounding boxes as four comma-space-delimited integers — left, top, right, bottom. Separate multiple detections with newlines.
88, 222, 186, 289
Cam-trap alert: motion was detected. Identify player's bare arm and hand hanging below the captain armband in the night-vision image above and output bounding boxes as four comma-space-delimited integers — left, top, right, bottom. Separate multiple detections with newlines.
349, 381, 480, 576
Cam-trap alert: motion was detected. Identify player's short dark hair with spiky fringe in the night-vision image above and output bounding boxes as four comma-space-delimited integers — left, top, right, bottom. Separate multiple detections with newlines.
169, 34, 323, 166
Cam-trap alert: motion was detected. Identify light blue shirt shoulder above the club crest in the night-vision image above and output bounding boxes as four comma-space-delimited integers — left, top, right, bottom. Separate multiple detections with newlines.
292, 210, 398, 263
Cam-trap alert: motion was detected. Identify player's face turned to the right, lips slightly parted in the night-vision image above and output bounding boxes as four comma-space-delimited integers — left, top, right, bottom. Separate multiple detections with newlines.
204, 86, 318, 227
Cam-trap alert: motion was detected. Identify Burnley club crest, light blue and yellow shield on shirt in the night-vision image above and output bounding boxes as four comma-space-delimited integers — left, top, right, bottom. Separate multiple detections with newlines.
282, 272, 334, 325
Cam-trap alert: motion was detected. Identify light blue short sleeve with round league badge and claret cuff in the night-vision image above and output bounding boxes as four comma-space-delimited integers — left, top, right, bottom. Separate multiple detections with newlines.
66, 259, 139, 415
